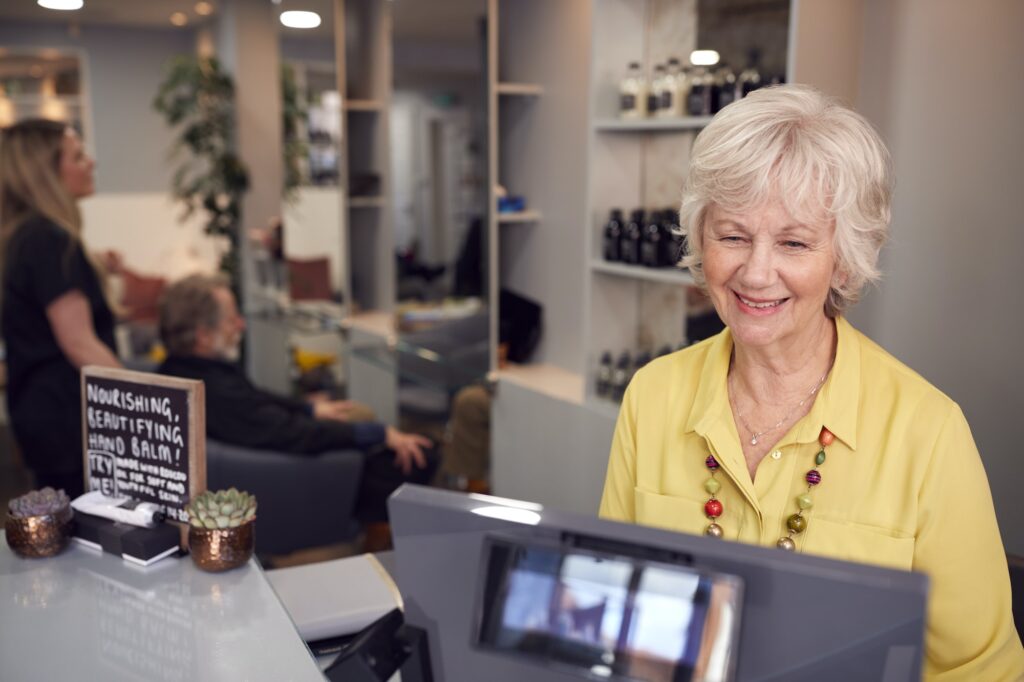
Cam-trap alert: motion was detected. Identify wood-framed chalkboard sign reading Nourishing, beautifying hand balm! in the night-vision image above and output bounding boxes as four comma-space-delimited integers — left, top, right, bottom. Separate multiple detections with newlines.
82, 367, 206, 523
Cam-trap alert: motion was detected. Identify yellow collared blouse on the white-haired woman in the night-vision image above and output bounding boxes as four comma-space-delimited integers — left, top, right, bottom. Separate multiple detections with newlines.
600, 318, 1024, 682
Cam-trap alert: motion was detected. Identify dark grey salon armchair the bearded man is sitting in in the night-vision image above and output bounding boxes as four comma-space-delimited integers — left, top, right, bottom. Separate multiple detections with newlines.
206, 439, 365, 556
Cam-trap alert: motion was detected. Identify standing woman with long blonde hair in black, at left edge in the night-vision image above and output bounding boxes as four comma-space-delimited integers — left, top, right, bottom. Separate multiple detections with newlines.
0, 120, 120, 497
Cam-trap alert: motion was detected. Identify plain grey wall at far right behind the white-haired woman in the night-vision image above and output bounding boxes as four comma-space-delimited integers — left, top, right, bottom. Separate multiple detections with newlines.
852, 0, 1024, 554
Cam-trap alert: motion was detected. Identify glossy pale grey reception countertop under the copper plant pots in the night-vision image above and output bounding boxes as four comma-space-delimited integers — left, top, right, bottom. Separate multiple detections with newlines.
0, 541, 324, 682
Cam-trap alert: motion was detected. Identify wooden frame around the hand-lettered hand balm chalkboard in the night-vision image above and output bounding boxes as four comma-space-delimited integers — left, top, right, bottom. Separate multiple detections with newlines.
81, 365, 206, 547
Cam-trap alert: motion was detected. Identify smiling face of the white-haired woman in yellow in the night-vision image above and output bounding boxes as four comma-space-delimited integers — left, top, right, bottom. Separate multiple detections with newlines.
703, 202, 837, 351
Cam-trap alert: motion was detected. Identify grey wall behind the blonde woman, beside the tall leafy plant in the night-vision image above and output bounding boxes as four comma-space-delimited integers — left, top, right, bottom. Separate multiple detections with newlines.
0, 22, 195, 193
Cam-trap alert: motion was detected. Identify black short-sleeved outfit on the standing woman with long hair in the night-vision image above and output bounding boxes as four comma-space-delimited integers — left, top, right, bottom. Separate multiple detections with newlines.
0, 216, 116, 472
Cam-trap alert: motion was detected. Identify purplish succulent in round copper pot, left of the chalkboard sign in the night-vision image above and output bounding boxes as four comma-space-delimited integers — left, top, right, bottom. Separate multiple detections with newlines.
4, 487, 74, 558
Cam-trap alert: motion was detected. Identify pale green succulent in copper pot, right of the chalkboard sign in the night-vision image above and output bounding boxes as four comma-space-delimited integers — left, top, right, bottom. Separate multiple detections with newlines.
186, 487, 256, 571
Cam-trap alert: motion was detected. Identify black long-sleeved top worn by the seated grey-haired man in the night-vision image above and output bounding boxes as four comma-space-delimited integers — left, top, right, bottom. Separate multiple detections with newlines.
159, 355, 385, 454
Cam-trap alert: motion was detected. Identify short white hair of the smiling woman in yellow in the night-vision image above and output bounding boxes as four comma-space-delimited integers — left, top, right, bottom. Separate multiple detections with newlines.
679, 85, 893, 317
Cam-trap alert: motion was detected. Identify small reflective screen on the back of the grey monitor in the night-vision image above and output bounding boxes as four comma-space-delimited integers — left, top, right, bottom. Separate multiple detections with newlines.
478, 542, 741, 682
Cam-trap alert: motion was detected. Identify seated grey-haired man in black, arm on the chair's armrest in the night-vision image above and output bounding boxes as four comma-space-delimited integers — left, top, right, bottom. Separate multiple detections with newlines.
159, 274, 437, 532
